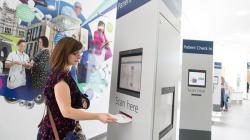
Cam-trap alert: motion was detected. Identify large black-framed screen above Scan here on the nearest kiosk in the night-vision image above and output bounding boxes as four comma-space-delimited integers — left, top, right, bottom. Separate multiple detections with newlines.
117, 49, 142, 97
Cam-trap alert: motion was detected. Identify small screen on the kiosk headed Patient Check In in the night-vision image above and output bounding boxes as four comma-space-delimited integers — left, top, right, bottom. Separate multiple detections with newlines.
188, 70, 206, 87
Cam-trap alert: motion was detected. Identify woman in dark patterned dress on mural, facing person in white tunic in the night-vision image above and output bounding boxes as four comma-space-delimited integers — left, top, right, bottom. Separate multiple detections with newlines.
32, 36, 50, 89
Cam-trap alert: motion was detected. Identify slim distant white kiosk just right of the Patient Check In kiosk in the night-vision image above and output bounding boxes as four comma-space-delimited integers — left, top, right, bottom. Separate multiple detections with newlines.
213, 62, 222, 112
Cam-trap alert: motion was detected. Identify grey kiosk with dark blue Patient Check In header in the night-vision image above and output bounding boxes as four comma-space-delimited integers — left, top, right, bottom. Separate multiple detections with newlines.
179, 39, 213, 140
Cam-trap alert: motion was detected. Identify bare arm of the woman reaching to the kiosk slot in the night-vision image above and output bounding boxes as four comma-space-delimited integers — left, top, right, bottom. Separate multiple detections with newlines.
54, 81, 116, 123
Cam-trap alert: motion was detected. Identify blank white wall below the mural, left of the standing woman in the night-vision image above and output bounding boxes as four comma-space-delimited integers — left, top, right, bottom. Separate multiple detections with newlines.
0, 96, 44, 140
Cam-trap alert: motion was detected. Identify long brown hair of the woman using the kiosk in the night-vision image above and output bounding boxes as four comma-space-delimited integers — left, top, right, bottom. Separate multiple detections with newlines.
50, 37, 83, 72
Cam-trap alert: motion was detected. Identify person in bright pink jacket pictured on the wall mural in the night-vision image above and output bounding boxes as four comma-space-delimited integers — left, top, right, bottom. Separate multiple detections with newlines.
93, 21, 112, 60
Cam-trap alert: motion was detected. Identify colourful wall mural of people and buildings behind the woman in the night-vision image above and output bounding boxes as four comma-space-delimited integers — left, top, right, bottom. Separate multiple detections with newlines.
0, 0, 117, 109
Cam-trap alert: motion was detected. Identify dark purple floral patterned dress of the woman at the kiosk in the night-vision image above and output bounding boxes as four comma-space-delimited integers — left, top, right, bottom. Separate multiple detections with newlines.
37, 72, 89, 140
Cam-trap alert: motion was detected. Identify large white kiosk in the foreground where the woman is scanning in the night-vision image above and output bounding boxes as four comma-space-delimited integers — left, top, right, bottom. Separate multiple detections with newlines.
107, 0, 181, 140
